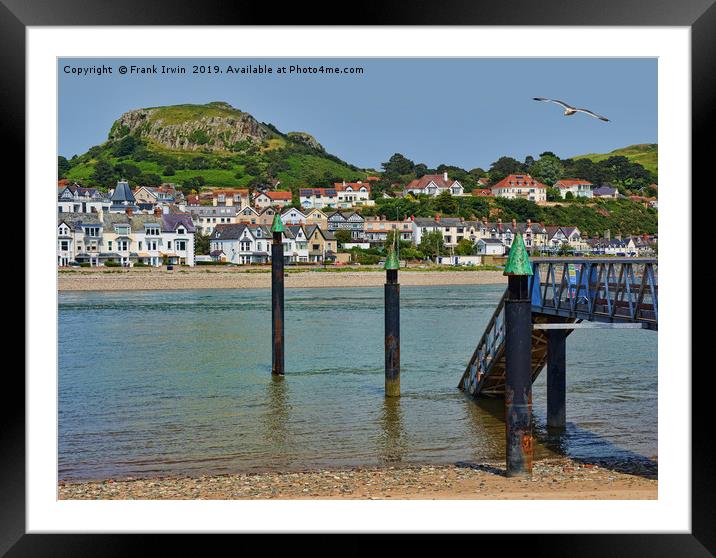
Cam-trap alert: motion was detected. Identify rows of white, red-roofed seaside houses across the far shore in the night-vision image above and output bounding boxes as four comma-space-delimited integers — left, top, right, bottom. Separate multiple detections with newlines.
57, 171, 658, 267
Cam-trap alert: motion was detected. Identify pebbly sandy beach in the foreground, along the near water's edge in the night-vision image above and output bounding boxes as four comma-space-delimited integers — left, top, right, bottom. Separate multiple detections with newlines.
59, 458, 658, 500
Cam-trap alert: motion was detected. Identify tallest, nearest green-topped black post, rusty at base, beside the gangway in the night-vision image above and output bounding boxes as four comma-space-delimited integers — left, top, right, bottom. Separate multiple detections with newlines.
504, 233, 532, 477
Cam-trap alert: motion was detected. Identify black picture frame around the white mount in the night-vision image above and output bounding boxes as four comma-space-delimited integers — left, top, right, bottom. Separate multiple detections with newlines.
7, 0, 704, 558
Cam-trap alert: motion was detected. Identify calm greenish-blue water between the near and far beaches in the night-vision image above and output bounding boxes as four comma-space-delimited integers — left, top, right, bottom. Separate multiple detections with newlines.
59, 285, 657, 479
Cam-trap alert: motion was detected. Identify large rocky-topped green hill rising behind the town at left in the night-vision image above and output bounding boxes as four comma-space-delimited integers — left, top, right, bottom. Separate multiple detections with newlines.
59, 102, 369, 192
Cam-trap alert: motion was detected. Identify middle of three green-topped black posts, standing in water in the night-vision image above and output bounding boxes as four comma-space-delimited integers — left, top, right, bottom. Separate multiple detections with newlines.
385, 246, 400, 397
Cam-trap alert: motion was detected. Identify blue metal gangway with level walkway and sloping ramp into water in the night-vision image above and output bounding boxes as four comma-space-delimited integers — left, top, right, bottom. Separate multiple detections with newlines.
458, 257, 658, 397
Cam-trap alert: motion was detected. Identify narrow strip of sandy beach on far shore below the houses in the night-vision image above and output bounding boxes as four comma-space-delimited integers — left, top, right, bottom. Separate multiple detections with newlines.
58, 267, 507, 291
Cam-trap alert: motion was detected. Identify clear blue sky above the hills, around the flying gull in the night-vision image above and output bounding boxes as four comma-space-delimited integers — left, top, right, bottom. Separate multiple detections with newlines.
58, 58, 658, 169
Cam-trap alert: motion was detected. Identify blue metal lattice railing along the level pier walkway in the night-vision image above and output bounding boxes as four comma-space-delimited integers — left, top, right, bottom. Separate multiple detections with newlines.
529, 258, 659, 330
